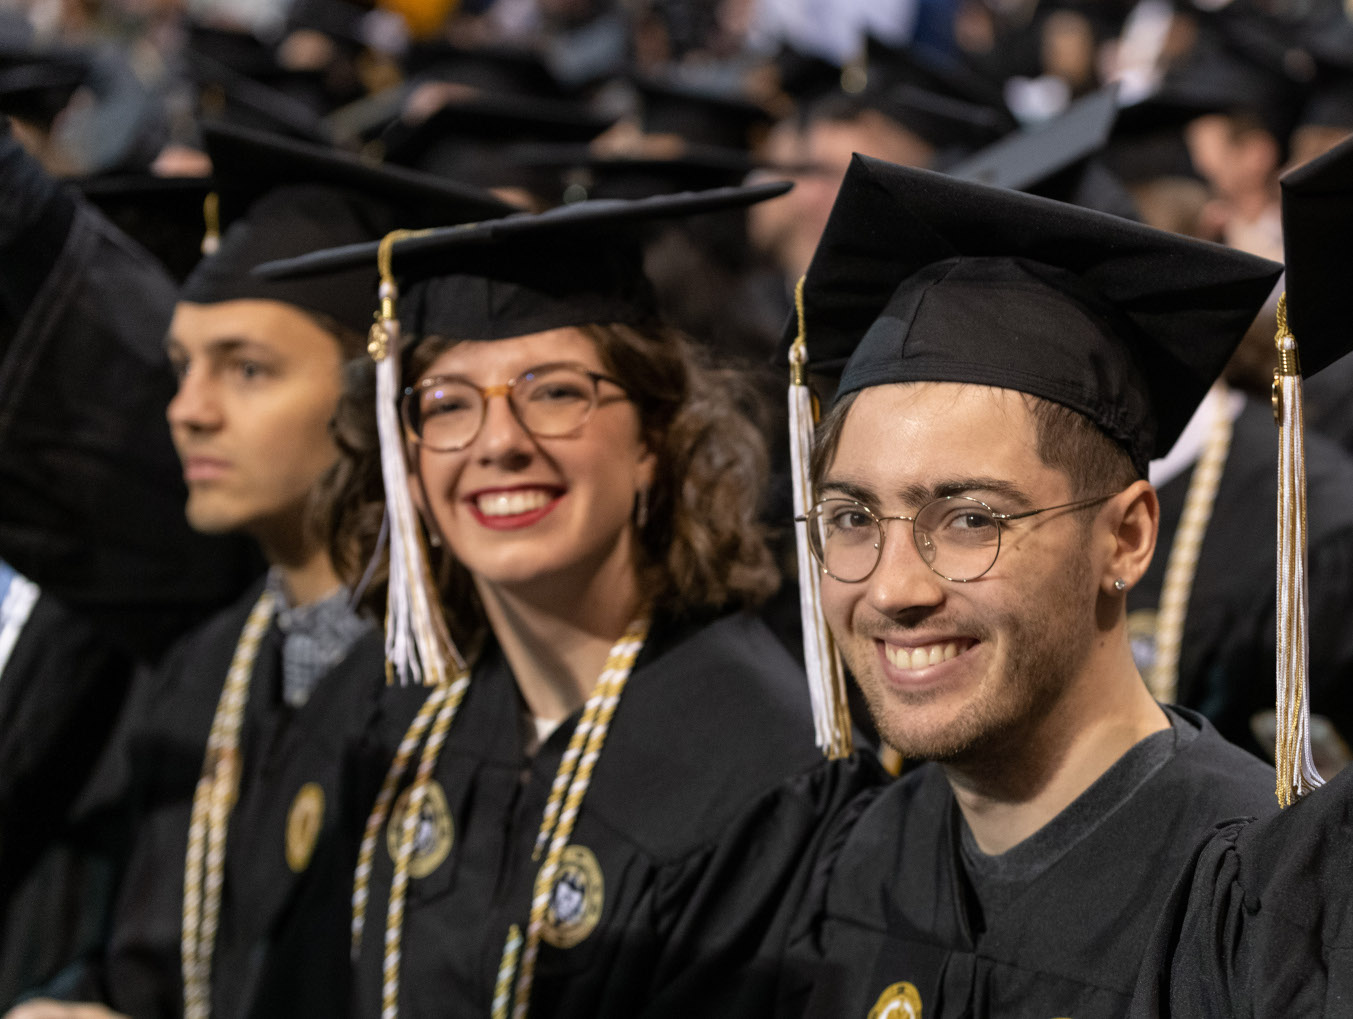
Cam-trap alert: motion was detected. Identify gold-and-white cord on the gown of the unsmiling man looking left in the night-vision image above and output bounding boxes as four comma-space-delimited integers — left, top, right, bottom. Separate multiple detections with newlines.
180, 590, 275, 1019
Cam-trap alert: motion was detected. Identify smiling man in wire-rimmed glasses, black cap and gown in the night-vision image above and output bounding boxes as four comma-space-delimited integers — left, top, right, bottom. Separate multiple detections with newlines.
782, 157, 1279, 1019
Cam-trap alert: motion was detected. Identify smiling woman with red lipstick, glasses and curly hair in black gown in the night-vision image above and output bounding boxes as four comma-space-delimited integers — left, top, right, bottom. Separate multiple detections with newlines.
276, 192, 877, 1016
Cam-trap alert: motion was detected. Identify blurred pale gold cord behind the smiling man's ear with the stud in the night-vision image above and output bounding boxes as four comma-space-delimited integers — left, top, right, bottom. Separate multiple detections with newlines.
1149, 382, 1235, 704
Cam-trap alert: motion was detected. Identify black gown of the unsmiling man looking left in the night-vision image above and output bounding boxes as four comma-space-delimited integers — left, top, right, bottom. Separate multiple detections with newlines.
67, 587, 422, 1019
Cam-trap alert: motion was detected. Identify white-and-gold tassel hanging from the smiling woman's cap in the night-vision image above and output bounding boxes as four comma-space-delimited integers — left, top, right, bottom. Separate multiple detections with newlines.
367, 231, 465, 685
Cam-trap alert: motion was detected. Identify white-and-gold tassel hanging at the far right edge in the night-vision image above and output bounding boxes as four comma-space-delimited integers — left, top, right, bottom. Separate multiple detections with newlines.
1273, 294, 1325, 807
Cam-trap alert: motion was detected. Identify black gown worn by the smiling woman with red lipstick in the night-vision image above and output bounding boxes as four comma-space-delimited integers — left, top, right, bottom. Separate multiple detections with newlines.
357, 614, 881, 1019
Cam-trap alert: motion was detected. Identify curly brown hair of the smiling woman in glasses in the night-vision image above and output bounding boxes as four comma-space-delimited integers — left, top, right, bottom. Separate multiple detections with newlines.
321, 323, 779, 648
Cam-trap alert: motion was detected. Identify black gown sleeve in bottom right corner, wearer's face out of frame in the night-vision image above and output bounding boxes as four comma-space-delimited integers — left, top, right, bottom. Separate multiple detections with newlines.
1131, 769, 1353, 1019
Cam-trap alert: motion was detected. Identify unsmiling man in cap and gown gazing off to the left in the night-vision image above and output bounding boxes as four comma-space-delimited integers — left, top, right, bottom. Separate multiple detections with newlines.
2, 127, 510, 1019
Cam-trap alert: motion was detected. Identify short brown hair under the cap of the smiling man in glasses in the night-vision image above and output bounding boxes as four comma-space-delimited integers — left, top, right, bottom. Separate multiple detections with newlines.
809, 390, 1142, 499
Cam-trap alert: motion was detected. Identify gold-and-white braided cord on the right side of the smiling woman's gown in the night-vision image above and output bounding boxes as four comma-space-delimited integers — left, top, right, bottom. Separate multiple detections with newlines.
495, 617, 649, 1019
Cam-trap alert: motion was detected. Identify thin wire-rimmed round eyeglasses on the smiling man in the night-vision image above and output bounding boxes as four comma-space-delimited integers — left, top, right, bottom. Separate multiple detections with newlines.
796, 493, 1118, 583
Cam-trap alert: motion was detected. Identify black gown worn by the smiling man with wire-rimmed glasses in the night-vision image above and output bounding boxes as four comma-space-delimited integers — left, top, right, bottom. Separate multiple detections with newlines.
782, 713, 1276, 1019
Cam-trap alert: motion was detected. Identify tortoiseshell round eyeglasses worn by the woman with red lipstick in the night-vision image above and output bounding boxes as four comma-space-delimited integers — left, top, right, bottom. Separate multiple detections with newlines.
400, 364, 628, 453
